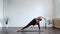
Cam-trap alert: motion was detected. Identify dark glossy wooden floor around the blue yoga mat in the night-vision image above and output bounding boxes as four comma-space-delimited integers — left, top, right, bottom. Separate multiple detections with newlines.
0, 27, 60, 34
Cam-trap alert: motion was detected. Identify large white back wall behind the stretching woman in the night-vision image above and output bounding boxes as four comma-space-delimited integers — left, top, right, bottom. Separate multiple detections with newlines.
4, 0, 53, 27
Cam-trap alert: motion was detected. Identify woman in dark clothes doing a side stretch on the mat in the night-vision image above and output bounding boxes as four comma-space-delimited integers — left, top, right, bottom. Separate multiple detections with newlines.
21, 16, 46, 30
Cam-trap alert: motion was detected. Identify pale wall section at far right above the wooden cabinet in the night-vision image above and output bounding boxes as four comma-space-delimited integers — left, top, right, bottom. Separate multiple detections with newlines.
54, 0, 60, 18
